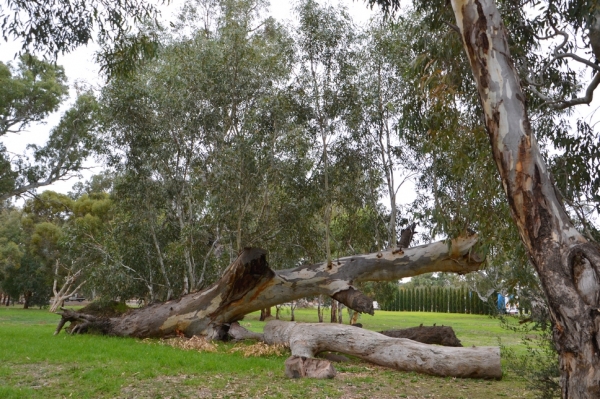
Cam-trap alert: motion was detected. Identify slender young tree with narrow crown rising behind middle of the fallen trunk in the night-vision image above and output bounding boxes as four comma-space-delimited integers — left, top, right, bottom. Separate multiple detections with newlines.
296, 0, 358, 268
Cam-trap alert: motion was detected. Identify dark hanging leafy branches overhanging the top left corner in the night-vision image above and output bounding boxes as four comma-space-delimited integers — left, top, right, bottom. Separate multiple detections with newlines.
0, 0, 164, 76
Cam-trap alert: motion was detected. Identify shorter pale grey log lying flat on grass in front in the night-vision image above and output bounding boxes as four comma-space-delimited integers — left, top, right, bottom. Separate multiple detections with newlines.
264, 320, 502, 379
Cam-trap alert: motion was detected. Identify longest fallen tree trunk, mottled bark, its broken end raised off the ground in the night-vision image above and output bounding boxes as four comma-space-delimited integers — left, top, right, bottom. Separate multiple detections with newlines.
56, 235, 481, 339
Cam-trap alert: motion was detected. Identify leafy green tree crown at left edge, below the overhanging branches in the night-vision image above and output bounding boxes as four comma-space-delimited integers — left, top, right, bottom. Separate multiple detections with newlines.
0, 55, 97, 201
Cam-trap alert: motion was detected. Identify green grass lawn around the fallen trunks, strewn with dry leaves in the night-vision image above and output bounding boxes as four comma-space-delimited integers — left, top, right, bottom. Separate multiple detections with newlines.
0, 307, 533, 399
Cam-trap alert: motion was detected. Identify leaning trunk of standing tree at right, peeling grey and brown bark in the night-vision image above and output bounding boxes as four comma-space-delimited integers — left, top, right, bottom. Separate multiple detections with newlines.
452, 0, 600, 399
